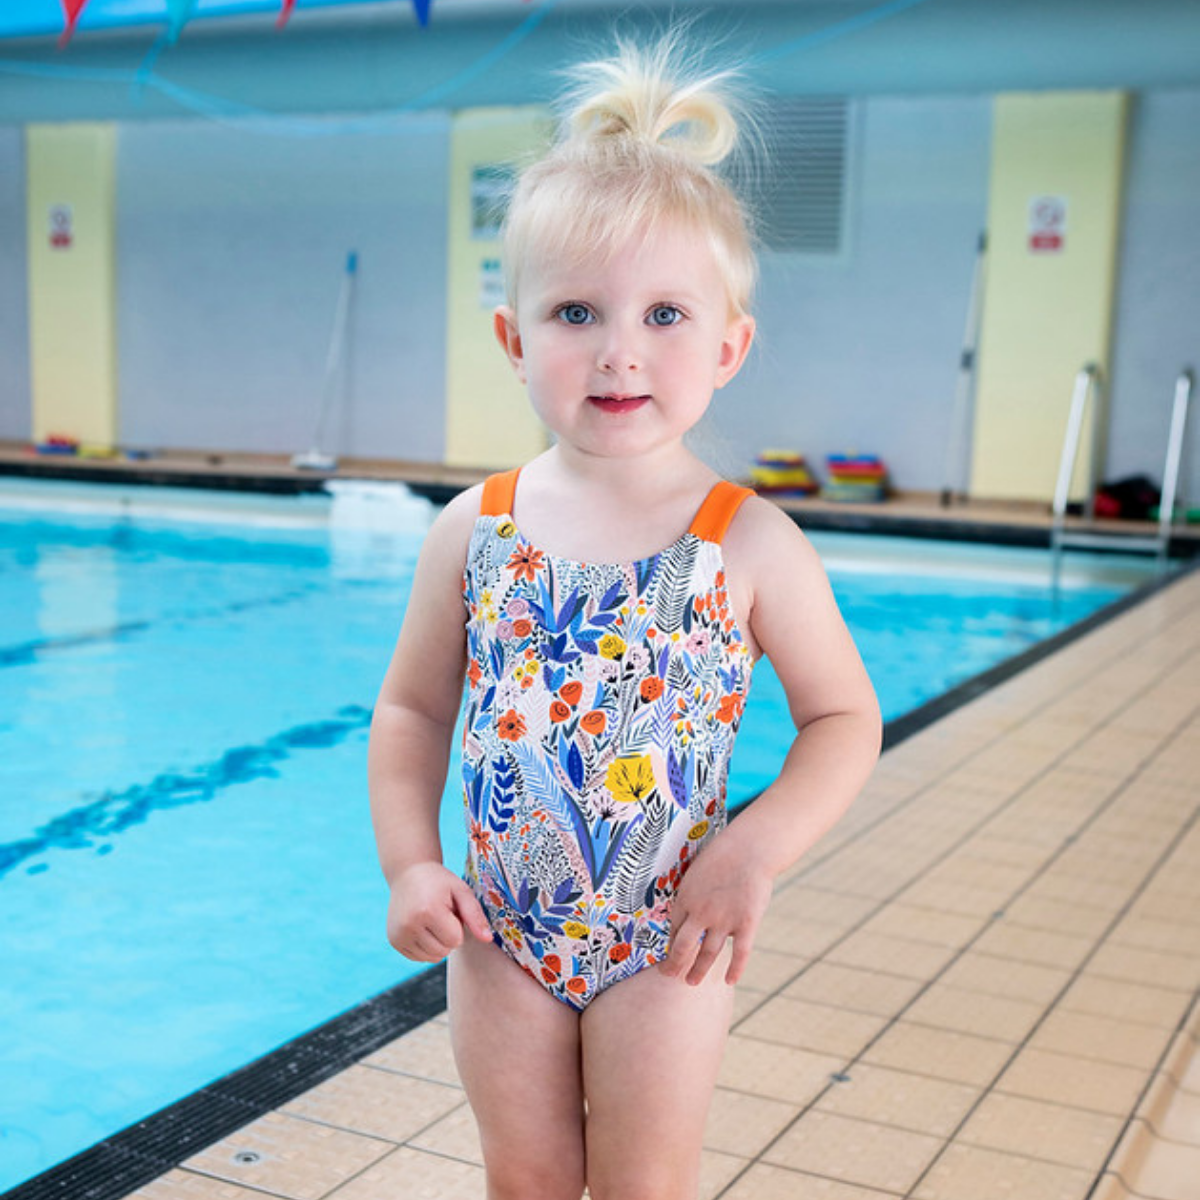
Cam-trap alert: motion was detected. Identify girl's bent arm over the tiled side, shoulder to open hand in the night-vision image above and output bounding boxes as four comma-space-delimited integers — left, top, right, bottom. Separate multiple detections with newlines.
662, 498, 881, 984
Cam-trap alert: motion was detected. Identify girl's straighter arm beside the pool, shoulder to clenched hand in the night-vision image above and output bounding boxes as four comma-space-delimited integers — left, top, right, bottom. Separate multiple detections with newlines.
367, 487, 492, 962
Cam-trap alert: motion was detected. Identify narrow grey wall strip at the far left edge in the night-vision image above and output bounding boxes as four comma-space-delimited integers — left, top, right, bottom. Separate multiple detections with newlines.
0, 127, 32, 442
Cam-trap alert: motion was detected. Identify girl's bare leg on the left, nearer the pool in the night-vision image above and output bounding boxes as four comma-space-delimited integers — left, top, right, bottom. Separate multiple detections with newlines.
449, 937, 583, 1200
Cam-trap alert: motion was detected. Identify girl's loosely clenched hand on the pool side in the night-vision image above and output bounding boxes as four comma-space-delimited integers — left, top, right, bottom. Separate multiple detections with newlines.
388, 863, 492, 962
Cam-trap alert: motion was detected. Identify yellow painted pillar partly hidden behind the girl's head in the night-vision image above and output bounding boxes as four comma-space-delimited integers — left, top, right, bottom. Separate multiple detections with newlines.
445, 108, 550, 467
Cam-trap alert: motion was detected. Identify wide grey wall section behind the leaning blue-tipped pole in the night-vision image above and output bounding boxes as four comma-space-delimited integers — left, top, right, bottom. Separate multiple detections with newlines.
118, 114, 449, 461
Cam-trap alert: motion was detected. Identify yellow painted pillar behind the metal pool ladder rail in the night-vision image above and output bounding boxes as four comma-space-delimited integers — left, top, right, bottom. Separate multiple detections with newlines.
971, 91, 1128, 500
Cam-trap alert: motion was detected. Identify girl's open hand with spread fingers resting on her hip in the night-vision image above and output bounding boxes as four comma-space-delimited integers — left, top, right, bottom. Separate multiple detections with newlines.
661, 827, 772, 986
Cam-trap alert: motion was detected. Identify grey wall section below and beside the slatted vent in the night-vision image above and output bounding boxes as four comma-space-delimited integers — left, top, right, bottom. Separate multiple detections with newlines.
714, 96, 991, 488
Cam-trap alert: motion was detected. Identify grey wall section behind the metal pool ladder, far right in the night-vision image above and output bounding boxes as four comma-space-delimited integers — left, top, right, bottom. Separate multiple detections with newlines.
1108, 90, 1200, 494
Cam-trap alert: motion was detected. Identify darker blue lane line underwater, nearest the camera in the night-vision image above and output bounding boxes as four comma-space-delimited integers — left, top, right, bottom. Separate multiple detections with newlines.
0, 704, 371, 880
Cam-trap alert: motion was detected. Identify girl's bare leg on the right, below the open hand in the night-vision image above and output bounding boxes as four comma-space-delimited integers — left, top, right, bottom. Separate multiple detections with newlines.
581, 952, 733, 1200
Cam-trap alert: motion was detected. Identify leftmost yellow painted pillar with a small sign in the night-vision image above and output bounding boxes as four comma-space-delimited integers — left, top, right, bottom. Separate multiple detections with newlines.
25, 124, 116, 448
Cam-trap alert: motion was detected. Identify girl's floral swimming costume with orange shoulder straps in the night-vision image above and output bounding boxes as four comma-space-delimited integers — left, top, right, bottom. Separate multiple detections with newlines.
462, 470, 752, 1009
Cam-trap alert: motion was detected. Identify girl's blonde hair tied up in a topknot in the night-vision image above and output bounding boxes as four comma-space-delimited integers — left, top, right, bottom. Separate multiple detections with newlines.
503, 34, 757, 313
